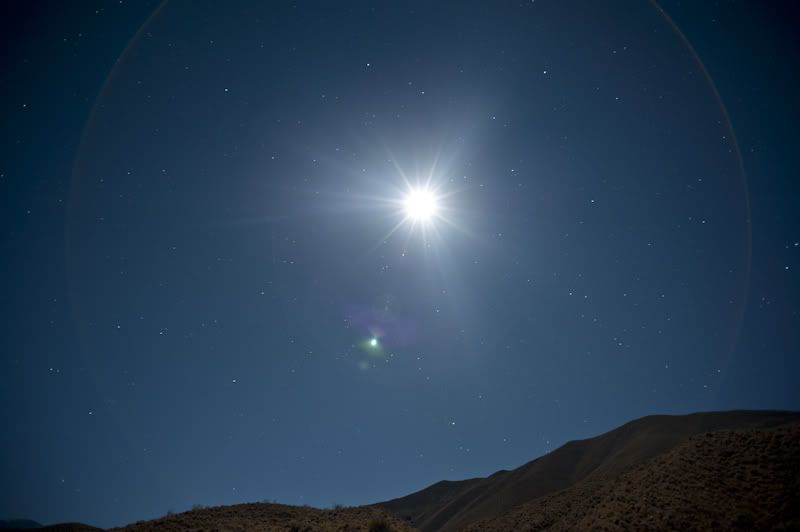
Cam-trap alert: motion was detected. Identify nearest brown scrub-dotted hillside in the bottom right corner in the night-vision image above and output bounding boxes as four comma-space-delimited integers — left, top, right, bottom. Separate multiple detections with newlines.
468, 424, 800, 532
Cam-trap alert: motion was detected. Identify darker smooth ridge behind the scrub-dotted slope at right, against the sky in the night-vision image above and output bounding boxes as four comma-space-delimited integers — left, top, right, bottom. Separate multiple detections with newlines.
378, 411, 800, 532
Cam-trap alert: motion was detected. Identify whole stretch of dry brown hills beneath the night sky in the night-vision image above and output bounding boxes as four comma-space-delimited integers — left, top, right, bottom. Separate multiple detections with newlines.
7, 411, 800, 532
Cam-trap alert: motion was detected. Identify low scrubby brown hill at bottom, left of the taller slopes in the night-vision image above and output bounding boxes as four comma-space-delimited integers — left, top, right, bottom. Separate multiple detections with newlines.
113, 503, 414, 532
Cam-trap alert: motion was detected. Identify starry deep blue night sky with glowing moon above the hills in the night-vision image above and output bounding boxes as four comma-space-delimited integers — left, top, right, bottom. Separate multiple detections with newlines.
0, 0, 800, 526
